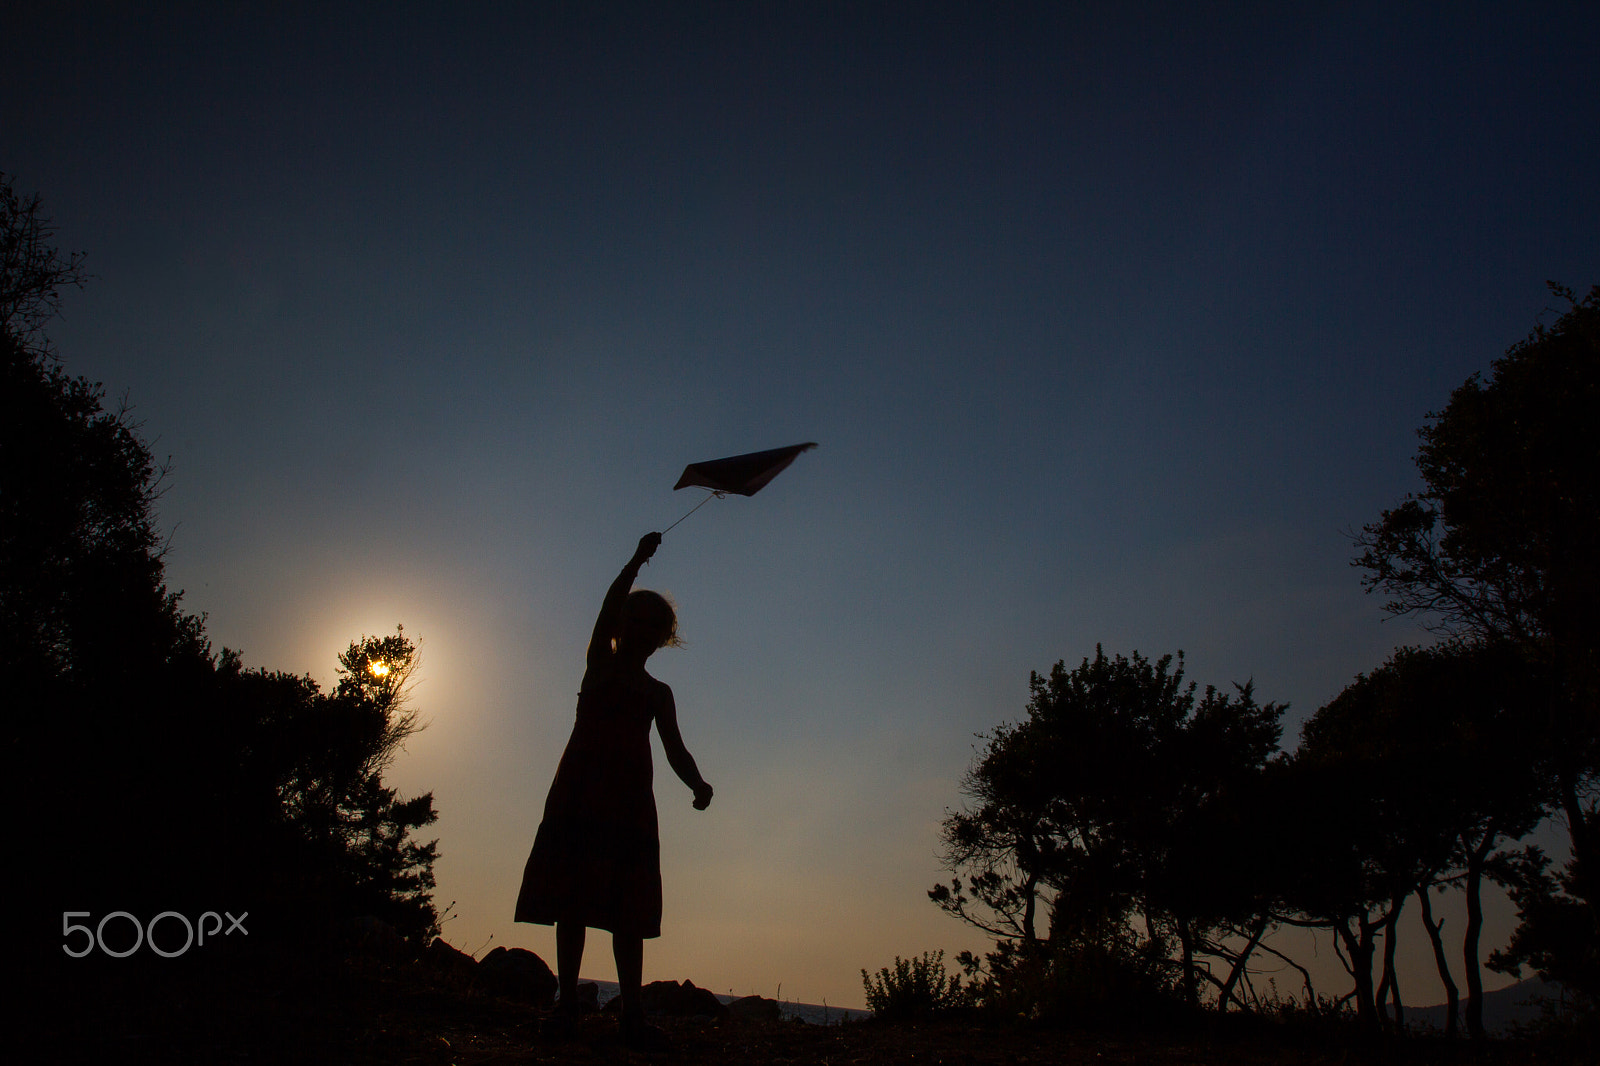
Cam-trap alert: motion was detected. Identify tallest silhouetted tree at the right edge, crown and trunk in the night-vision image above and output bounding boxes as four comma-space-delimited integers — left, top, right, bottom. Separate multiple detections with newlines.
1355, 283, 1600, 1024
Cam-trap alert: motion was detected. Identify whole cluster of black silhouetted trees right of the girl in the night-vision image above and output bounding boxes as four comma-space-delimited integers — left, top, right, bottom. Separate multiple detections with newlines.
930, 287, 1600, 1034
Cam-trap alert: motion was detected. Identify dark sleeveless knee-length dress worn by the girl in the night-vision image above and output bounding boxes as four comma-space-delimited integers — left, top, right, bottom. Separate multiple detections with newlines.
515, 667, 664, 938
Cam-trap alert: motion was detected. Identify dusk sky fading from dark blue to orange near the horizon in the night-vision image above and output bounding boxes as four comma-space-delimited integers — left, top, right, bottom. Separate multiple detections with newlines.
0, 2, 1600, 1005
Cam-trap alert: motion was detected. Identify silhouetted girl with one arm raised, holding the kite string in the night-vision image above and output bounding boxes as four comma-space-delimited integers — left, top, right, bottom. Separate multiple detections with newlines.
517, 533, 712, 1047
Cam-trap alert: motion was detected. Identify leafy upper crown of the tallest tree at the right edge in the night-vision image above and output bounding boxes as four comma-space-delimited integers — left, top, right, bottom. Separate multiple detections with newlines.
1355, 278, 1600, 656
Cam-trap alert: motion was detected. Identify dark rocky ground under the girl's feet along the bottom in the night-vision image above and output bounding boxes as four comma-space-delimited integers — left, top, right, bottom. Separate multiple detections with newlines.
31, 967, 1586, 1066
